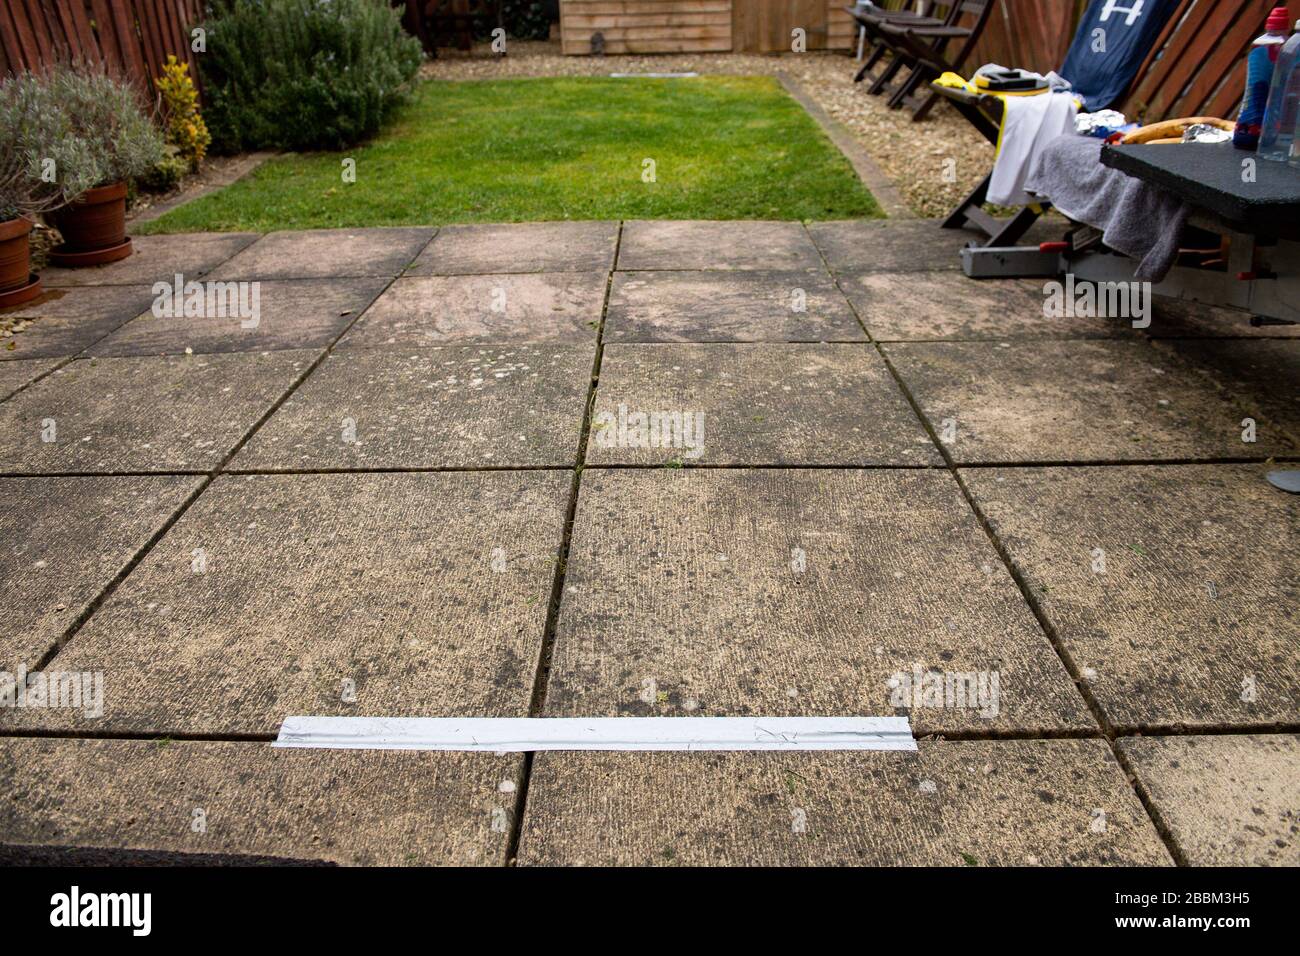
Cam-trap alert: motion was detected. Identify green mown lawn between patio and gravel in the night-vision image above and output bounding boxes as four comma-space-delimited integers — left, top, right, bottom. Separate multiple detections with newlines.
133, 77, 881, 233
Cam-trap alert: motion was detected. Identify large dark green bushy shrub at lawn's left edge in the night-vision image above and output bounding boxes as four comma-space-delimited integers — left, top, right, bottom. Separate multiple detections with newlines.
200, 0, 421, 152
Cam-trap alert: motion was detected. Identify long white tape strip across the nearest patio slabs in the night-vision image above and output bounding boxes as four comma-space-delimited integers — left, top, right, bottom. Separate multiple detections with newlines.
273, 717, 917, 753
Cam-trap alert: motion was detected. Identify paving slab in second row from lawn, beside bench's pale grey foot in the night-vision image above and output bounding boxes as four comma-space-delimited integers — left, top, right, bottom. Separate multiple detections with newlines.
840, 272, 1136, 342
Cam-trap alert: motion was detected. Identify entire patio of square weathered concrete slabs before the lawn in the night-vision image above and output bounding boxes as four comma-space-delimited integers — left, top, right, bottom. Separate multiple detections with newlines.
0, 221, 1300, 865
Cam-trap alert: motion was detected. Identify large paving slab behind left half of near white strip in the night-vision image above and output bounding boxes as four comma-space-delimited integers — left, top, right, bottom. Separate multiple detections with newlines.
12, 472, 571, 735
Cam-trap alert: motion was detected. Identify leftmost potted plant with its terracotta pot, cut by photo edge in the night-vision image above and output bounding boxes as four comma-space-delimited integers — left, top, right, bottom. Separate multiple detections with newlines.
0, 73, 99, 308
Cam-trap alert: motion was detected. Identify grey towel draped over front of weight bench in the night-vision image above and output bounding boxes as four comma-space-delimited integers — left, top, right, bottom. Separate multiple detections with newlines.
1024, 134, 1188, 282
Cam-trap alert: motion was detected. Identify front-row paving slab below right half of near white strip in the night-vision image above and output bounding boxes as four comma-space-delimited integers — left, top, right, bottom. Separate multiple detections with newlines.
519, 740, 1171, 866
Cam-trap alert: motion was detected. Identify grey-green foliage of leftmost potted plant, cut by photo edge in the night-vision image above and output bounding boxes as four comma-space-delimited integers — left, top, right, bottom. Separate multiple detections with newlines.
0, 73, 103, 221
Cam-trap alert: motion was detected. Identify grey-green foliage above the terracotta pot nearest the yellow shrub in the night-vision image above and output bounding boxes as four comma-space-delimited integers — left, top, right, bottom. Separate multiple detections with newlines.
46, 66, 166, 186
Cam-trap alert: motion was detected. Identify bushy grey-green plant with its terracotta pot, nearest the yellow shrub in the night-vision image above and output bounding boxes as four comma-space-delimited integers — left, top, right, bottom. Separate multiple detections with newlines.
49, 68, 165, 267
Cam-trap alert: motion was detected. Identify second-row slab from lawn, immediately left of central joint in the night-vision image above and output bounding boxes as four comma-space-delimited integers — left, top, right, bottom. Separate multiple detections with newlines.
339, 272, 608, 349
